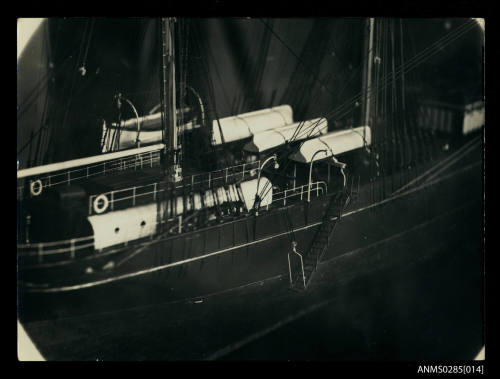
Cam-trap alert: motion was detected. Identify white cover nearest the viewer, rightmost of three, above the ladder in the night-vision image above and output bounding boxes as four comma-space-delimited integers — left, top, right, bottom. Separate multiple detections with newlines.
289, 126, 371, 163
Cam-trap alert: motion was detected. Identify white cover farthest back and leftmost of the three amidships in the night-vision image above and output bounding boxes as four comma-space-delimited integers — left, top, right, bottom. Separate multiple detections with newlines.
212, 105, 293, 145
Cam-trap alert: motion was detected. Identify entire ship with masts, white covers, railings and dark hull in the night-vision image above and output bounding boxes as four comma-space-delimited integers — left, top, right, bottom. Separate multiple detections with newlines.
17, 18, 484, 318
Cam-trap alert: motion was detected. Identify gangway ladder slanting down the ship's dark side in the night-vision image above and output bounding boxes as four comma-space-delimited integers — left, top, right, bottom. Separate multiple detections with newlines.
288, 191, 349, 291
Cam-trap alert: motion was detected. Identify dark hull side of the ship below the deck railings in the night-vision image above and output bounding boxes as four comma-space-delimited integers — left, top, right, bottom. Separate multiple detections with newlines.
19, 138, 482, 320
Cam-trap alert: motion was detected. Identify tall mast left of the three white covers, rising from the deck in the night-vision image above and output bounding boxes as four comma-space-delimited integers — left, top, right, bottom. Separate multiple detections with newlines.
161, 17, 182, 182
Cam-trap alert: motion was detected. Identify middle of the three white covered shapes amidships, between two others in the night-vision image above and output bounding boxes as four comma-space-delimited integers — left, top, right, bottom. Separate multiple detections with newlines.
243, 118, 328, 153
